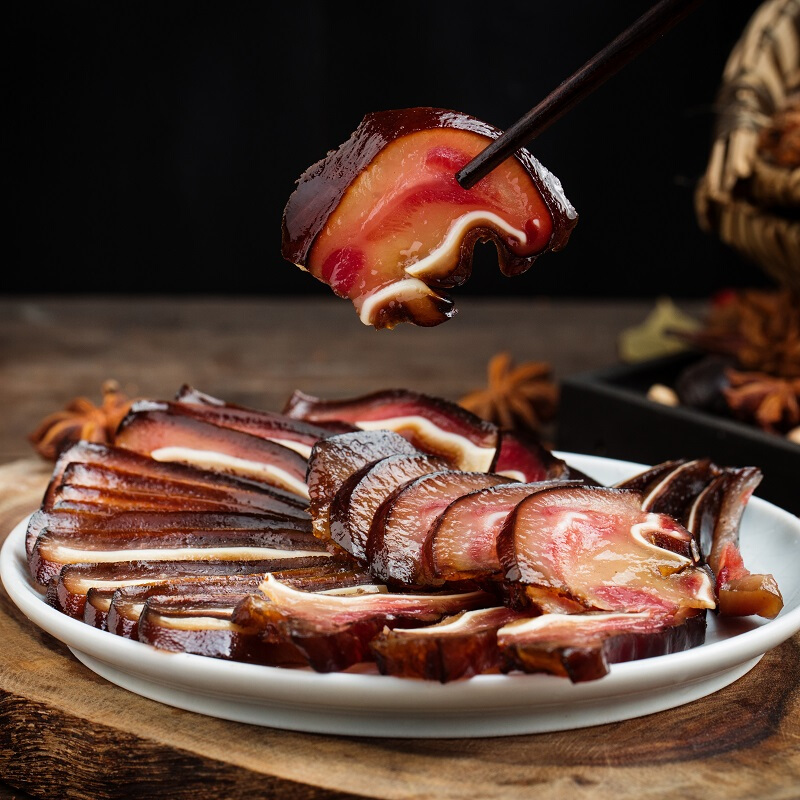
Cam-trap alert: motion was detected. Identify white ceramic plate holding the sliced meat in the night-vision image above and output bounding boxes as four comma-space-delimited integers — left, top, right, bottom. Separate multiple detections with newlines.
0, 454, 800, 738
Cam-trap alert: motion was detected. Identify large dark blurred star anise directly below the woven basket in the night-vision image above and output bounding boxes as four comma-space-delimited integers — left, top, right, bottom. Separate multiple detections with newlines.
686, 289, 800, 378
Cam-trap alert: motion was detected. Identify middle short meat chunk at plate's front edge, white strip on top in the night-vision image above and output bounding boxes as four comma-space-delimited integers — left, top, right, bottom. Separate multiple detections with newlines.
370, 608, 520, 683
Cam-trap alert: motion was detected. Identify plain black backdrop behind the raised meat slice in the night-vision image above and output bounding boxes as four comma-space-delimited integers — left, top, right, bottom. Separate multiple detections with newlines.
4, 0, 766, 296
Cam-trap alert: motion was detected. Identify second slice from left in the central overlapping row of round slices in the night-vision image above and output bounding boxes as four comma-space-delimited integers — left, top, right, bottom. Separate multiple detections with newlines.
330, 455, 447, 562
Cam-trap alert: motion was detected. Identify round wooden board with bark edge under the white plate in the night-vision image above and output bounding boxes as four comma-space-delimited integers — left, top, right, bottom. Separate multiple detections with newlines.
0, 460, 800, 800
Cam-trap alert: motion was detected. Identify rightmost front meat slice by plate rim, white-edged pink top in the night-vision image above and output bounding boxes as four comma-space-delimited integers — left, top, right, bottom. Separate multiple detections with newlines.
497, 609, 706, 683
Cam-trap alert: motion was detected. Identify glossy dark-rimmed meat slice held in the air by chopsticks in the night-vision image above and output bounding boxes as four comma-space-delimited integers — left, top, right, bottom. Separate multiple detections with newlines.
282, 108, 577, 328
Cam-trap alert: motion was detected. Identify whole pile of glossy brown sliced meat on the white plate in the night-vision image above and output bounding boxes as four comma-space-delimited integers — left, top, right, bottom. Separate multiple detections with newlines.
26, 387, 782, 681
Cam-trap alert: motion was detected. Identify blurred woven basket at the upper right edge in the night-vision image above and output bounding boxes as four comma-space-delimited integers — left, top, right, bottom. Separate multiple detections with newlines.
695, 0, 800, 291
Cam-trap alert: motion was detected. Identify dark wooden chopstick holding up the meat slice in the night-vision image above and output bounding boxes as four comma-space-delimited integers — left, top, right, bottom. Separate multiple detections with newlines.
456, 0, 703, 189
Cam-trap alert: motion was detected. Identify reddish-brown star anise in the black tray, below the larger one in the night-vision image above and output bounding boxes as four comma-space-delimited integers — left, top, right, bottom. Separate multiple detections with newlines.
723, 369, 800, 433
